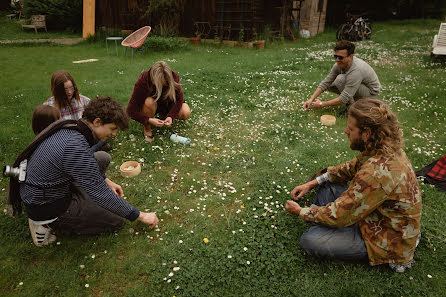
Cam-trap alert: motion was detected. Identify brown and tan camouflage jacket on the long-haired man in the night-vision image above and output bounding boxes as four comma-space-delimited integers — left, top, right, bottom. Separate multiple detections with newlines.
300, 151, 421, 265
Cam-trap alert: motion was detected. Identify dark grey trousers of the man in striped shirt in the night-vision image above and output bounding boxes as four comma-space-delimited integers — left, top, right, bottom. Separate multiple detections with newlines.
49, 151, 124, 234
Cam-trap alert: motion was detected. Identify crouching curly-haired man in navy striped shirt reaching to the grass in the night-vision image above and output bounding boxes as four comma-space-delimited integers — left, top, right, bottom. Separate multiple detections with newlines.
20, 97, 158, 246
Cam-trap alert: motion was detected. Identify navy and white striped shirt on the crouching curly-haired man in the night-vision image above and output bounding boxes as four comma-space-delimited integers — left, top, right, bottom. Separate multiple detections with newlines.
20, 129, 139, 221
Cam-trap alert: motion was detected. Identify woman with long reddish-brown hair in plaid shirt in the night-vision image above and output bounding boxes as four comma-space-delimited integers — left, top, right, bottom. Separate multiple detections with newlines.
43, 70, 90, 120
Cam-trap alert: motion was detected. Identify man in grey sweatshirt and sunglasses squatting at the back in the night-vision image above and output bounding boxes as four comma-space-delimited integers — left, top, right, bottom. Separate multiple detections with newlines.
303, 40, 381, 110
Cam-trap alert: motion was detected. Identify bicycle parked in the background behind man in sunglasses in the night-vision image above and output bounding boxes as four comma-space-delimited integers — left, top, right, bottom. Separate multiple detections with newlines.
336, 14, 372, 41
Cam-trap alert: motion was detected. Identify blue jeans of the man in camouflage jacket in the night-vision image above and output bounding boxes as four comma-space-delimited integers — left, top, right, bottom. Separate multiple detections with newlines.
300, 182, 367, 260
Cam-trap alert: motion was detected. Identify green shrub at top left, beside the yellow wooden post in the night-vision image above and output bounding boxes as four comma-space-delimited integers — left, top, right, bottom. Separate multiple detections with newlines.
24, 0, 82, 31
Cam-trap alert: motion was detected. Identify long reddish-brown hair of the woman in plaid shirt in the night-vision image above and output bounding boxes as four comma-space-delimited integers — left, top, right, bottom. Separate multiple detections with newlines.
51, 70, 80, 109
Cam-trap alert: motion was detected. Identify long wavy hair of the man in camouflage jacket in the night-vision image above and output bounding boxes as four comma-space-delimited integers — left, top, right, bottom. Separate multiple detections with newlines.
348, 99, 404, 156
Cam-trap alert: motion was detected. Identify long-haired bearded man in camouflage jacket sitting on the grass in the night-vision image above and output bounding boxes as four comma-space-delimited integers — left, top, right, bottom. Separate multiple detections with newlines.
285, 99, 421, 272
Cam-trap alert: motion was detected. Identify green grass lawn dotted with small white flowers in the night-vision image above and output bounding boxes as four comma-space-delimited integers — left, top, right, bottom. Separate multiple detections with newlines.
0, 20, 446, 296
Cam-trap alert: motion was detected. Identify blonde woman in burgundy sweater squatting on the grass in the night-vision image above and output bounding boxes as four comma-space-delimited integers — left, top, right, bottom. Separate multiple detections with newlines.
127, 61, 190, 142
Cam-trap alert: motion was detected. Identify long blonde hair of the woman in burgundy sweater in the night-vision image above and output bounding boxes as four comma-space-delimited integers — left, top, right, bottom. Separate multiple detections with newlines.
150, 61, 181, 102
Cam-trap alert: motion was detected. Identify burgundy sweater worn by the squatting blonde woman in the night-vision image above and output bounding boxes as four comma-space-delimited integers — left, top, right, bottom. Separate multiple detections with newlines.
127, 69, 184, 126
